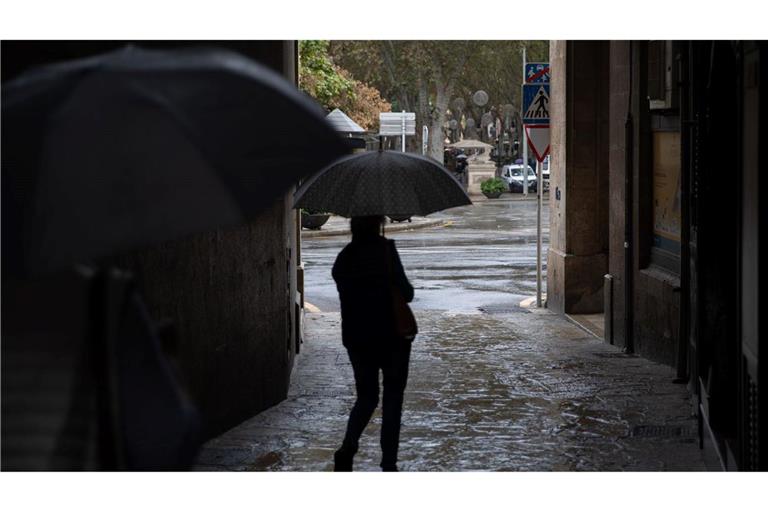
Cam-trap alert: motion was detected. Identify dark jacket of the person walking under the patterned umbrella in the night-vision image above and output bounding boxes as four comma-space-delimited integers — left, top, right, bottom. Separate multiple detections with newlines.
332, 236, 413, 348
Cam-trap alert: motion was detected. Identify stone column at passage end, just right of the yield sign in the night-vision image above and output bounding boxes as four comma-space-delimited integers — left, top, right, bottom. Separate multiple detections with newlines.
547, 41, 609, 313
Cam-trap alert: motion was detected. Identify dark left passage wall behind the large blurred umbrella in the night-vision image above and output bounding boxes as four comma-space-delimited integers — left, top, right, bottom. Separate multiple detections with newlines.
2, 41, 300, 436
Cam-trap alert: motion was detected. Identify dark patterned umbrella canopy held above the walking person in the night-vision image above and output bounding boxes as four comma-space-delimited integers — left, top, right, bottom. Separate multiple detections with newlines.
294, 151, 472, 217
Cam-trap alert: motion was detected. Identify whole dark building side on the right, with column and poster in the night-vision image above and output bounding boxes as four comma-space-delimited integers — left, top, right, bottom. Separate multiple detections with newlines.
547, 41, 768, 470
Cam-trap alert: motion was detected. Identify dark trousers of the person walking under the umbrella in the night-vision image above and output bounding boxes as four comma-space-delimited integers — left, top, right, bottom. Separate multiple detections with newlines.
341, 340, 411, 468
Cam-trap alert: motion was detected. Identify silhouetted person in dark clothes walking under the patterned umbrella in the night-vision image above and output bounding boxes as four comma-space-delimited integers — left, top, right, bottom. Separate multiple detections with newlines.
332, 216, 413, 471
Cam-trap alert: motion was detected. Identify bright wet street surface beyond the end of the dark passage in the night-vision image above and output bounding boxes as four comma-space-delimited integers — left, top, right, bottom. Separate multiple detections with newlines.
302, 196, 549, 312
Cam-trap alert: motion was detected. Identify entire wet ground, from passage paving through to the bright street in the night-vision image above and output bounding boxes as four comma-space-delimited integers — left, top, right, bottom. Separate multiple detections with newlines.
197, 195, 704, 471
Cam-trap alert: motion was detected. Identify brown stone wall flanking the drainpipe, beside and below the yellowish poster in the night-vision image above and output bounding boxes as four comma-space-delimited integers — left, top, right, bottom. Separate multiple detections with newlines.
607, 41, 680, 365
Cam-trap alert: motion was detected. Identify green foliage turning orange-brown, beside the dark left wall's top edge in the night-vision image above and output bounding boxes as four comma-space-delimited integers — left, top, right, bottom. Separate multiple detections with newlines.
299, 41, 392, 130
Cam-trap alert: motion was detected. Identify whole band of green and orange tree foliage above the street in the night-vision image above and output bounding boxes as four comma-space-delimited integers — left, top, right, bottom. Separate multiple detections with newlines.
299, 40, 549, 160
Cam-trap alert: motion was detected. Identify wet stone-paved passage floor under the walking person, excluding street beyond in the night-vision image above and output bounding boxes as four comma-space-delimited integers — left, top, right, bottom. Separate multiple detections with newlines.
196, 308, 705, 471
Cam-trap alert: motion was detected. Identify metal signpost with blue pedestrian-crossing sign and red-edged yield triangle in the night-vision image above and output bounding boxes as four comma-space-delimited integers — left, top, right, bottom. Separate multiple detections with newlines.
521, 59, 550, 307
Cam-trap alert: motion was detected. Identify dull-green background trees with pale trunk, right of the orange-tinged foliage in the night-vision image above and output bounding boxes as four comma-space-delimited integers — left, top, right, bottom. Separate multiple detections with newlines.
329, 41, 549, 161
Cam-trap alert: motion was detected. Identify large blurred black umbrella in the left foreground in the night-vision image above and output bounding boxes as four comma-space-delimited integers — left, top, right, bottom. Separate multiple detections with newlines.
2, 47, 347, 275
